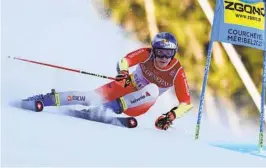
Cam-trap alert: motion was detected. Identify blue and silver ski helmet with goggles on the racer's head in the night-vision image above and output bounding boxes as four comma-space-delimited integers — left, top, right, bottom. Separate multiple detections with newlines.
151, 32, 178, 58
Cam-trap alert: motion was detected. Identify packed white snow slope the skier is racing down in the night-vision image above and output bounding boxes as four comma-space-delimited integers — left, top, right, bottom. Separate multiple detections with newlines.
1, 0, 266, 166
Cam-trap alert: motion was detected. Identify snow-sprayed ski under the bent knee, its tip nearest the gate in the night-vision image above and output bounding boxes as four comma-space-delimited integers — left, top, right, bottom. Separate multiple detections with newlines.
64, 109, 138, 128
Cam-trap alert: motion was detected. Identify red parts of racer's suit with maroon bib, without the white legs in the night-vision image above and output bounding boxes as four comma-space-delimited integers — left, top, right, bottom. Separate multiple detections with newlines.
96, 48, 191, 116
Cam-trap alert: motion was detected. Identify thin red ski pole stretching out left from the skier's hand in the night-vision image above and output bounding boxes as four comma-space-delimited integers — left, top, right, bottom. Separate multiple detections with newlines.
8, 56, 115, 80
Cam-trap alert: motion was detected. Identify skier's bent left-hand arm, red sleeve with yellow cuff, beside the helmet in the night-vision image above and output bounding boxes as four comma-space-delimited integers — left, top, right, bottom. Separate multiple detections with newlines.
117, 48, 151, 72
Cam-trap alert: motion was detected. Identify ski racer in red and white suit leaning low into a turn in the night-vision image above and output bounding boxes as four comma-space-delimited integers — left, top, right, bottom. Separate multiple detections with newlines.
22, 32, 193, 130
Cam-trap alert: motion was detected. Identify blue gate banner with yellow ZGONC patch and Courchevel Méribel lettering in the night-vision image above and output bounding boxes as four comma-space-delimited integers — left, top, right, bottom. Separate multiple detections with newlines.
211, 0, 266, 51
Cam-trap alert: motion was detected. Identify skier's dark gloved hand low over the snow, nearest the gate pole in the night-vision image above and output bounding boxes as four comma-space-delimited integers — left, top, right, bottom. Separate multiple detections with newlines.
155, 111, 176, 130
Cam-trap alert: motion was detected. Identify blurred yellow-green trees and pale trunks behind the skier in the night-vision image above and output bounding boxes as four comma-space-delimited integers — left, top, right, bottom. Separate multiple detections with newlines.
93, 0, 263, 134
